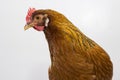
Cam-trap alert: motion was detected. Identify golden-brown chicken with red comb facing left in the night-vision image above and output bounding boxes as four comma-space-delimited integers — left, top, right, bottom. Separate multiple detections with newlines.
24, 8, 113, 80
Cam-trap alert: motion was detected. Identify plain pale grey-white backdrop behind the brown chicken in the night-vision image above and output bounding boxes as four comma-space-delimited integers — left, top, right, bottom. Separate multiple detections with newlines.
0, 0, 120, 80
